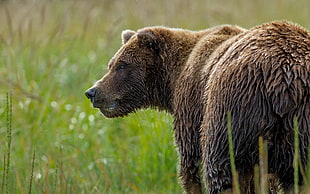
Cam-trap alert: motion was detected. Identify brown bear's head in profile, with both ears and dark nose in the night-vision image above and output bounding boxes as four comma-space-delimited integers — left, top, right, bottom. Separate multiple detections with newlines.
85, 29, 162, 118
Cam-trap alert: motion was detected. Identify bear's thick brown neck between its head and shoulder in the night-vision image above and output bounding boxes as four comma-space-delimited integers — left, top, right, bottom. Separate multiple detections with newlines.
151, 31, 203, 113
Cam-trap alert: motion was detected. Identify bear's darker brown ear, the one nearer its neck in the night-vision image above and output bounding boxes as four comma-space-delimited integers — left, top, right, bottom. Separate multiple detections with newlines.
137, 30, 159, 51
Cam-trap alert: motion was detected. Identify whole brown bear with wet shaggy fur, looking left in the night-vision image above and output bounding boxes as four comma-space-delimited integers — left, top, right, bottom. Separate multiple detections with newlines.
86, 21, 310, 193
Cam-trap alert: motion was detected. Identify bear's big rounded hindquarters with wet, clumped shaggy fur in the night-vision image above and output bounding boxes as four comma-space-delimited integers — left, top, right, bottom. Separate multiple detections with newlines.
201, 22, 310, 193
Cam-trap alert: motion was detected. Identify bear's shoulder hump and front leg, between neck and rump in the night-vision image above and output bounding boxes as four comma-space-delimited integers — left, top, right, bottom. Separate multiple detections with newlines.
173, 26, 244, 193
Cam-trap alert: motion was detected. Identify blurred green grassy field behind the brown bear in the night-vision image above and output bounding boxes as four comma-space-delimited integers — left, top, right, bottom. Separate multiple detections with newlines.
0, 0, 310, 193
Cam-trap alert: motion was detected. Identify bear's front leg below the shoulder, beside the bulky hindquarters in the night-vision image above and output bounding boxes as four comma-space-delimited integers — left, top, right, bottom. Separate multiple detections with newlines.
174, 79, 203, 194
